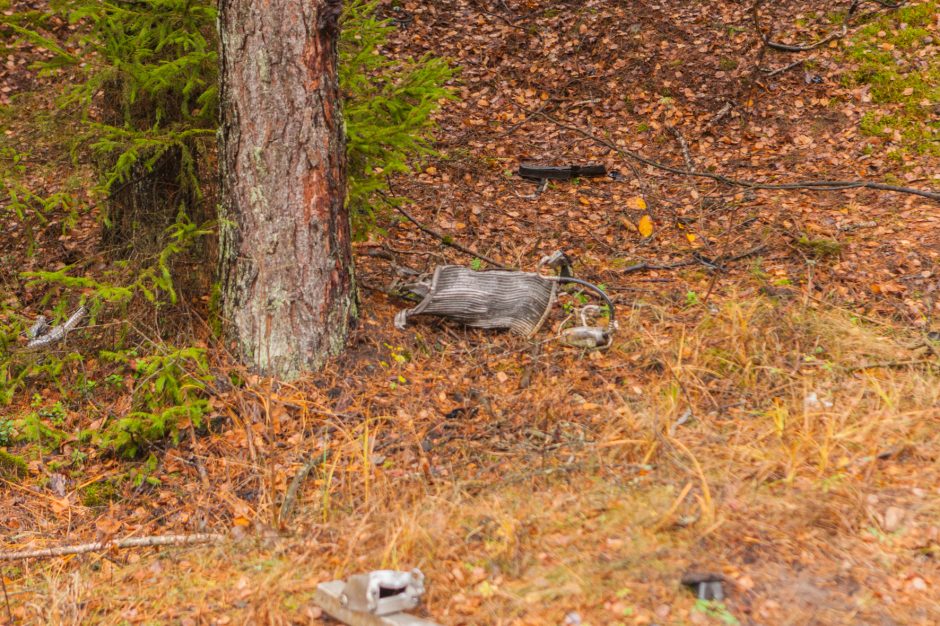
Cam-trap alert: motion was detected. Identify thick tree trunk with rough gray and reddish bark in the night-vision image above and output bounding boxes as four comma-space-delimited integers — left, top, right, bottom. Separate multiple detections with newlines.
219, 0, 356, 378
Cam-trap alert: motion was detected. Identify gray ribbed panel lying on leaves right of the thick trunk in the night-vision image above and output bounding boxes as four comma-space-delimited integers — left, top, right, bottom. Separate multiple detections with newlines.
395, 265, 558, 337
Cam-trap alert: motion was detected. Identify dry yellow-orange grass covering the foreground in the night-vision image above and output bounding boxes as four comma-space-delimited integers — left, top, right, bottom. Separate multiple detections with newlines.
14, 294, 940, 625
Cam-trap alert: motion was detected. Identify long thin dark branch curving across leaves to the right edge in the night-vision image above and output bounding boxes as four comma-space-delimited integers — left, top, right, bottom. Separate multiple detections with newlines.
539, 113, 940, 202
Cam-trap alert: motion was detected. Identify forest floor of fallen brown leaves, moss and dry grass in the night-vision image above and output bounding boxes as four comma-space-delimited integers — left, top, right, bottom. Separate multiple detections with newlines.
0, 0, 940, 626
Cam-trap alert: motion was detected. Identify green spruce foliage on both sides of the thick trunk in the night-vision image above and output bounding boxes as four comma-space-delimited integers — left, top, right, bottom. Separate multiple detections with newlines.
0, 0, 453, 456
